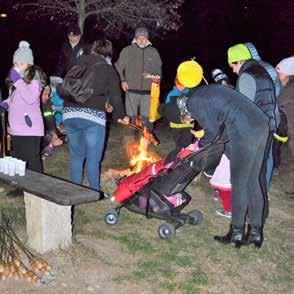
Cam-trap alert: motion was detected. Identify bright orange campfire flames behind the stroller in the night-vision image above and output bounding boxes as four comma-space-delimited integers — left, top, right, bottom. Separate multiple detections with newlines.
128, 136, 161, 173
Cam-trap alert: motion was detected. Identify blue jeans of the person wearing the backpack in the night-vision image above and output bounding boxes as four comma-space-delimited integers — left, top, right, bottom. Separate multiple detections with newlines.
64, 118, 105, 190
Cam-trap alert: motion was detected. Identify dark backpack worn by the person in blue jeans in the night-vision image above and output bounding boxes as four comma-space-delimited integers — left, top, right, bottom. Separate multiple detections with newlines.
58, 62, 103, 104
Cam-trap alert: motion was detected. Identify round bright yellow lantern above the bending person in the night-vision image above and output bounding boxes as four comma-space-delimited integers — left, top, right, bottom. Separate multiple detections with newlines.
177, 60, 203, 88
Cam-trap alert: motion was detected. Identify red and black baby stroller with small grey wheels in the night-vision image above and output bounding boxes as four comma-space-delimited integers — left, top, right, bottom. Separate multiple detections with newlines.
104, 139, 224, 240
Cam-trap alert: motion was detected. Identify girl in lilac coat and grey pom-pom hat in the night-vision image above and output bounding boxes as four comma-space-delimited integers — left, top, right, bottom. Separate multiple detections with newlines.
2, 41, 44, 172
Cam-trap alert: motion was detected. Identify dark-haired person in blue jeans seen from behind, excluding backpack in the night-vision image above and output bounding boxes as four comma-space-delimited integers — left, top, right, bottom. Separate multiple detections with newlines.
59, 40, 128, 190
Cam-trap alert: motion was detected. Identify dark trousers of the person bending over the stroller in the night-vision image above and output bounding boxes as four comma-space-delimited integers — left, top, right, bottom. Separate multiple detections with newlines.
230, 132, 272, 227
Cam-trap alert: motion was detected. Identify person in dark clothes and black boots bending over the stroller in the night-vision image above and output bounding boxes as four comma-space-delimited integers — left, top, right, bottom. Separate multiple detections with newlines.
161, 84, 269, 247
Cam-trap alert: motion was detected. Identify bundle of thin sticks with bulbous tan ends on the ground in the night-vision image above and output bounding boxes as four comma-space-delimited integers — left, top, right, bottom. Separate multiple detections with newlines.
0, 213, 51, 284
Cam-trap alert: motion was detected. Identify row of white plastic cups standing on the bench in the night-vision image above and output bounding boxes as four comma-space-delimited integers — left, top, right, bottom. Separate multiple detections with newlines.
0, 156, 26, 176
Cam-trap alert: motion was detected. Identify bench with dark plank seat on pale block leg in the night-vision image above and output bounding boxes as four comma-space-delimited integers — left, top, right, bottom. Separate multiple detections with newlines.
0, 169, 101, 253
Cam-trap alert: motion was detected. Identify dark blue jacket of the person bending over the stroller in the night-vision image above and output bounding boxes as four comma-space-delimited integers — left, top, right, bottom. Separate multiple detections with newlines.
187, 84, 269, 157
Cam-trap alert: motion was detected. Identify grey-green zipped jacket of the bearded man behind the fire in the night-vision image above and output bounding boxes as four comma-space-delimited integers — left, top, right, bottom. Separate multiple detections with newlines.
115, 43, 162, 92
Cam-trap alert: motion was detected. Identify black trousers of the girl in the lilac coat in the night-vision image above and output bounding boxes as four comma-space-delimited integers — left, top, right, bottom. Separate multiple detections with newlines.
12, 136, 43, 173
